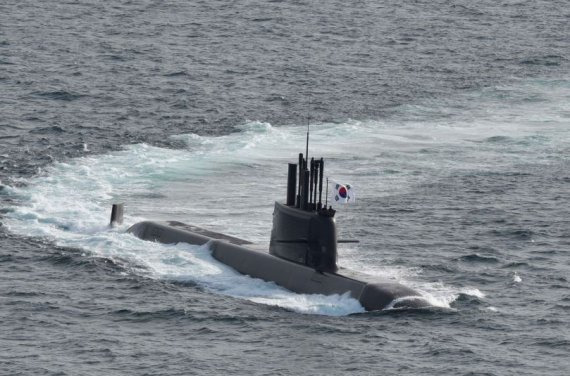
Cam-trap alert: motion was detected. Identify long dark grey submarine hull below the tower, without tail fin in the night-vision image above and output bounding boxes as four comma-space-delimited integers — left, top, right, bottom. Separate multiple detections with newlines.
128, 221, 429, 311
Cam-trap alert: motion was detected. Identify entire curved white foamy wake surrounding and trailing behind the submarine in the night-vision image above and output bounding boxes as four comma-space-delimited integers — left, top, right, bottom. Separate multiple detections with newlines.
5, 80, 570, 314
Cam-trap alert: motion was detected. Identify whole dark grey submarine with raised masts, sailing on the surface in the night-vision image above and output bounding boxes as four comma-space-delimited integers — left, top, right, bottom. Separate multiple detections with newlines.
117, 142, 429, 311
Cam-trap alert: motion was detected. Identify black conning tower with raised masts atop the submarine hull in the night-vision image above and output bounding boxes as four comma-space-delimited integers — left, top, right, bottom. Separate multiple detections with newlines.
269, 153, 338, 273
